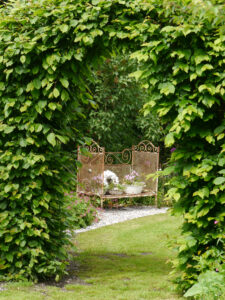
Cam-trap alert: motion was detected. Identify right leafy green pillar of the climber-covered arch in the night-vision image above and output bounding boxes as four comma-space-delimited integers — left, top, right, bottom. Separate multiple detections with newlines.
139, 2, 225, 290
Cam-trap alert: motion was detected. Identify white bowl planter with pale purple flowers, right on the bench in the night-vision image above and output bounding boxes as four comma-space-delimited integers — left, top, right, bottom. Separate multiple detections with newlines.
124, 170, 145, 195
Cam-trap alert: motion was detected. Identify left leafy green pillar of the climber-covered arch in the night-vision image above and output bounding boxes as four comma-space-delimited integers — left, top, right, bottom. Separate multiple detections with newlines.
0, 1, 98, 279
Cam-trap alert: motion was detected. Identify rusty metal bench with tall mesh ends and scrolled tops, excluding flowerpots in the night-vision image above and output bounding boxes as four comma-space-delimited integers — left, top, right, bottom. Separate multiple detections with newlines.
77, 140, 159, 205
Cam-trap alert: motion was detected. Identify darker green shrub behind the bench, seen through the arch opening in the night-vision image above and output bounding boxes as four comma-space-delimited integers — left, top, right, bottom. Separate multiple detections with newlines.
84, 54, 162, 151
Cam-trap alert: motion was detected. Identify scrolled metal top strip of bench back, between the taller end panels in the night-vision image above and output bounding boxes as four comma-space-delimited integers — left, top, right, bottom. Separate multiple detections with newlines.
105, 149, 132, 165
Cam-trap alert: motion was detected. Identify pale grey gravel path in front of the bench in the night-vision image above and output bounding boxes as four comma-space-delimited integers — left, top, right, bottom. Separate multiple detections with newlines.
75, 206, 168, 233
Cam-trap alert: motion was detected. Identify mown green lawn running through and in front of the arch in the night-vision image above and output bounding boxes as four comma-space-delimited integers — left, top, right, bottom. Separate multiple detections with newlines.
0, 214, 185, 300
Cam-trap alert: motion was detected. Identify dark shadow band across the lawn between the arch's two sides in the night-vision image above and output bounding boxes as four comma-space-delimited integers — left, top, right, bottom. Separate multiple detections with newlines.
77, 252, 171, 280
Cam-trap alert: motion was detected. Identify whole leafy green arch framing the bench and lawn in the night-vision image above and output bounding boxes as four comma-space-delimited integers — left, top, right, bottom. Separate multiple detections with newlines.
0, 0, 225, 290
